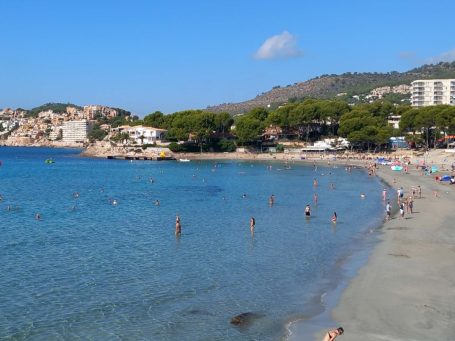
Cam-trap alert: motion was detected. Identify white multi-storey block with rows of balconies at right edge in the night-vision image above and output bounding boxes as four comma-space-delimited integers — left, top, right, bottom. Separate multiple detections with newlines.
411, 79, 455, 107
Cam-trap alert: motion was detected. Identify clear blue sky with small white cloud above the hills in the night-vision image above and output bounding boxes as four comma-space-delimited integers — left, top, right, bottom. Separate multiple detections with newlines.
0, 0, 455, 117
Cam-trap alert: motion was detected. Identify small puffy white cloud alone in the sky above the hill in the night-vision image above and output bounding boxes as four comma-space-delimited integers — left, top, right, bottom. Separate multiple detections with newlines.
254, 31, 303, 59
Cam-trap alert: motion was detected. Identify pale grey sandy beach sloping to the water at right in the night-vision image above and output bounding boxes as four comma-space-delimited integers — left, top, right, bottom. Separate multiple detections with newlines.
300, 152, 455, 341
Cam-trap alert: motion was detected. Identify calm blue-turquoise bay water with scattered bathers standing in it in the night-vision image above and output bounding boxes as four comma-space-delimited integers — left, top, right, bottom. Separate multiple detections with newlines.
0, 147, 383, 340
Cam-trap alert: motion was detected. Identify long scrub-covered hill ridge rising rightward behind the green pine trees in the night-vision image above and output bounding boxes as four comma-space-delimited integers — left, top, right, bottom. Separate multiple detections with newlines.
206, 62, 455, 114
